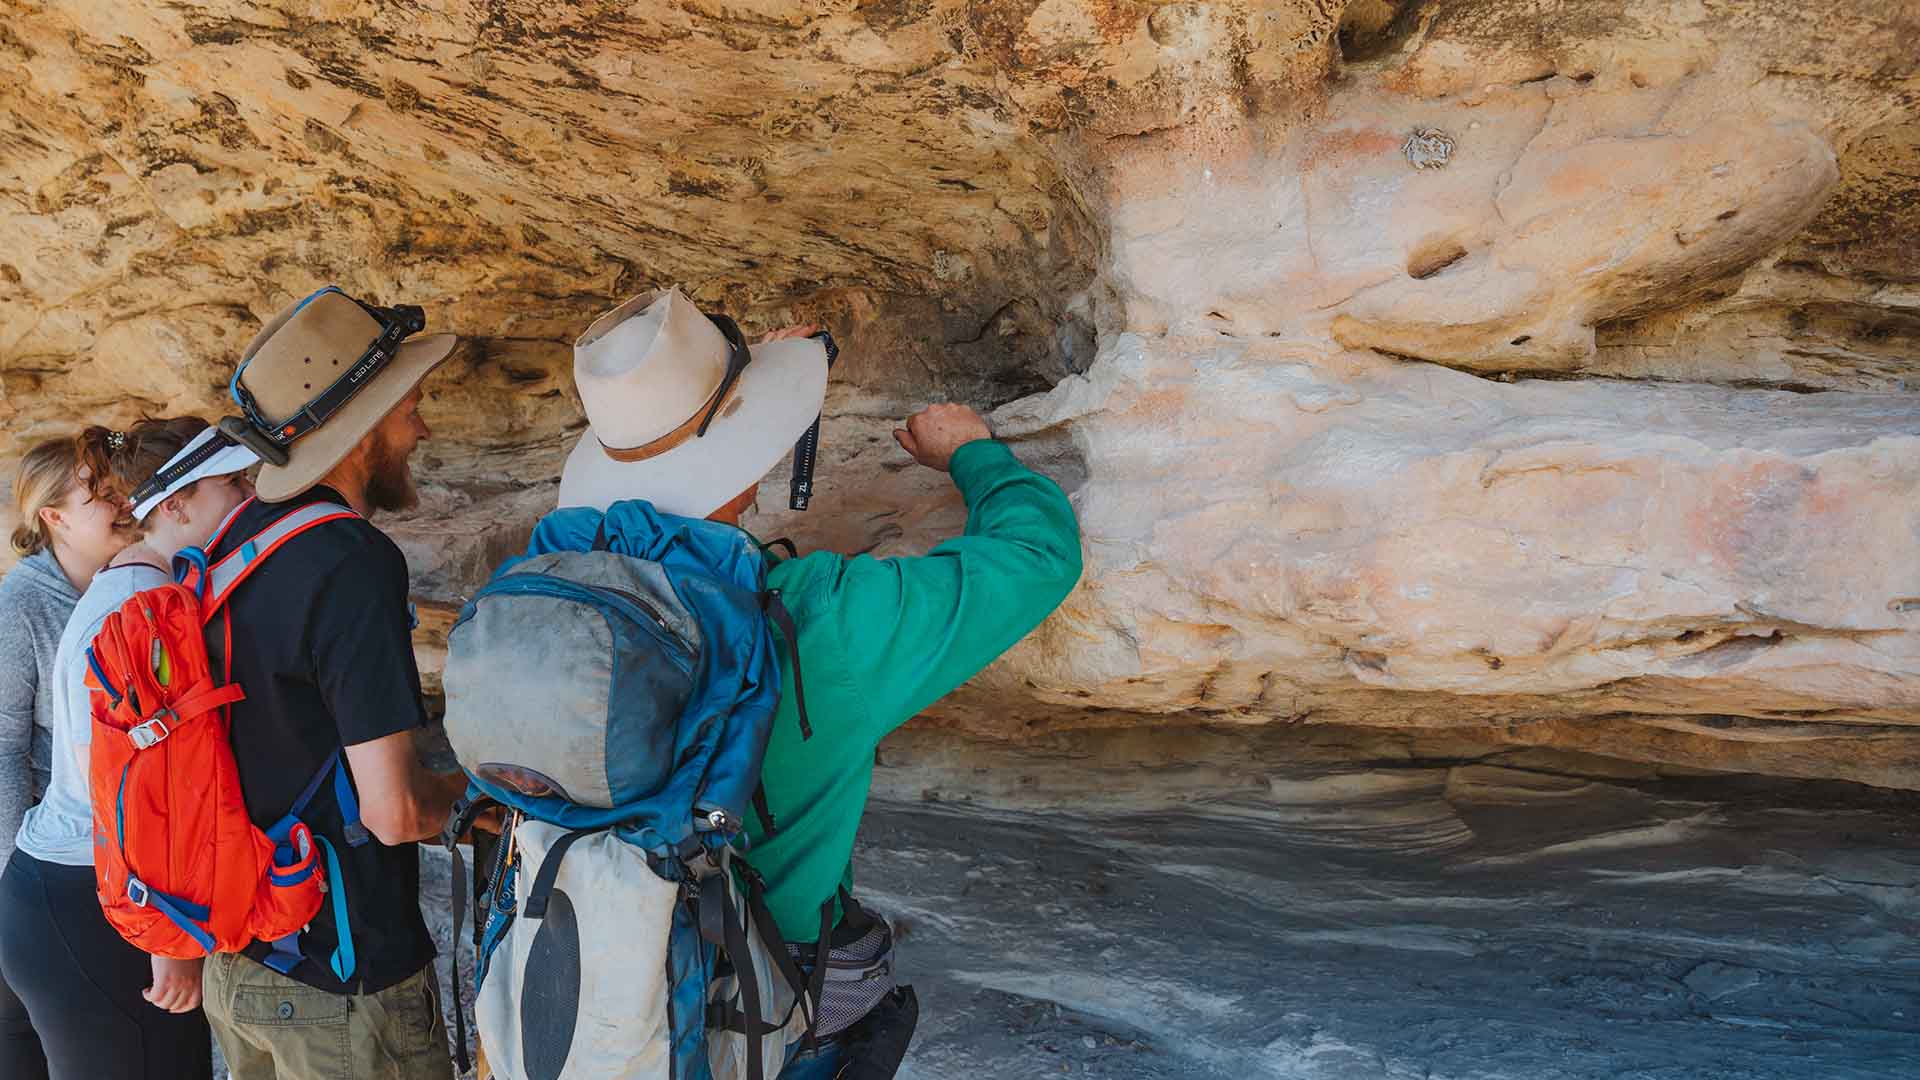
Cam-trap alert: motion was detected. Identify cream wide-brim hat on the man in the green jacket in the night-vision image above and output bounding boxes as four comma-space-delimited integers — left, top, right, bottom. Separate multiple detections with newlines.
559, 288, 828, 517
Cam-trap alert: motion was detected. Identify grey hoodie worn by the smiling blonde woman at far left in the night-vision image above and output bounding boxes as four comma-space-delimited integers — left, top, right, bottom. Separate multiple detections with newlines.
0, 550, 81, 859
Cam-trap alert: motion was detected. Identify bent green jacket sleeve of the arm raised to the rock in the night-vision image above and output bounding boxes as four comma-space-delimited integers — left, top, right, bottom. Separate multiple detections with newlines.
806, 440, 1081, 742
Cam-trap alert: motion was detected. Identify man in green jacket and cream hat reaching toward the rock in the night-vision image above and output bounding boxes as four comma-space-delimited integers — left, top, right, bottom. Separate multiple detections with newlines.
559, 290, 1081, 1080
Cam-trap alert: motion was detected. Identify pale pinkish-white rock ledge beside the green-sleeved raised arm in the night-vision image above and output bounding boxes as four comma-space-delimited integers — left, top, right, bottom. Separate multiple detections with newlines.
755, 336, 1920, 786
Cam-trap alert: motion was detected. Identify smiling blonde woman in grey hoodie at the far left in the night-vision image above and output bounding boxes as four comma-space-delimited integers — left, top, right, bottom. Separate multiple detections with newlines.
0, 430, 131, 1080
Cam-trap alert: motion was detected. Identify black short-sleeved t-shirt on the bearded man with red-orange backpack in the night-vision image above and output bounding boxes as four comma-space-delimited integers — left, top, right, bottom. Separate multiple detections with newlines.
207, 488, 434, 994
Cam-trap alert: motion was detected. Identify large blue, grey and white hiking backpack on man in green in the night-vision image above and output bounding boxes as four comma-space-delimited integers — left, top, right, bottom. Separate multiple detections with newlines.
445, 502, 812, 1080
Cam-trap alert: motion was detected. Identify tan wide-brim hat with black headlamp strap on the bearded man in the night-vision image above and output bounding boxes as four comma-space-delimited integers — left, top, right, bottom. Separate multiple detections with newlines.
232, 286, 459, 502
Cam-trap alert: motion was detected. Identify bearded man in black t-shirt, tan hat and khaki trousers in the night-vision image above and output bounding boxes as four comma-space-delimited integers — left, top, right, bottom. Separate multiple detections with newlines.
204, 288, 465, 1080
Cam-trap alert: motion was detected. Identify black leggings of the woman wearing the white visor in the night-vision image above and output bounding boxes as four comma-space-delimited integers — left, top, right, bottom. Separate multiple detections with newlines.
0, 851, 213, 1080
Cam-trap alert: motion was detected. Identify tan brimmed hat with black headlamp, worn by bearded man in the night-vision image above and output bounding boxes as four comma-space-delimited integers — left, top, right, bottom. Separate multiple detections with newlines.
236, 288, 459, 502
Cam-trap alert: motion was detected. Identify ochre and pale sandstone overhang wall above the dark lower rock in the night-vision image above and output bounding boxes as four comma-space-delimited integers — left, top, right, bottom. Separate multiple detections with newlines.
0, 0, 1920, 788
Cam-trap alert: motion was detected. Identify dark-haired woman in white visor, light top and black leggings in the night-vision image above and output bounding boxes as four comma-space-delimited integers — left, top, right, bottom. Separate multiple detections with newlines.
0, 417, 257, 1080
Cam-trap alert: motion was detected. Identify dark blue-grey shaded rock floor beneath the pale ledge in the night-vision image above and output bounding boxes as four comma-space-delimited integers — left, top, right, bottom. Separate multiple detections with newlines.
397, 718, 1920, 1080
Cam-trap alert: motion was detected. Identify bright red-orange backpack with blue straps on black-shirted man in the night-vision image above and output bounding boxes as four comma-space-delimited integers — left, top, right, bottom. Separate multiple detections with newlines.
86, 500, 367, 980
